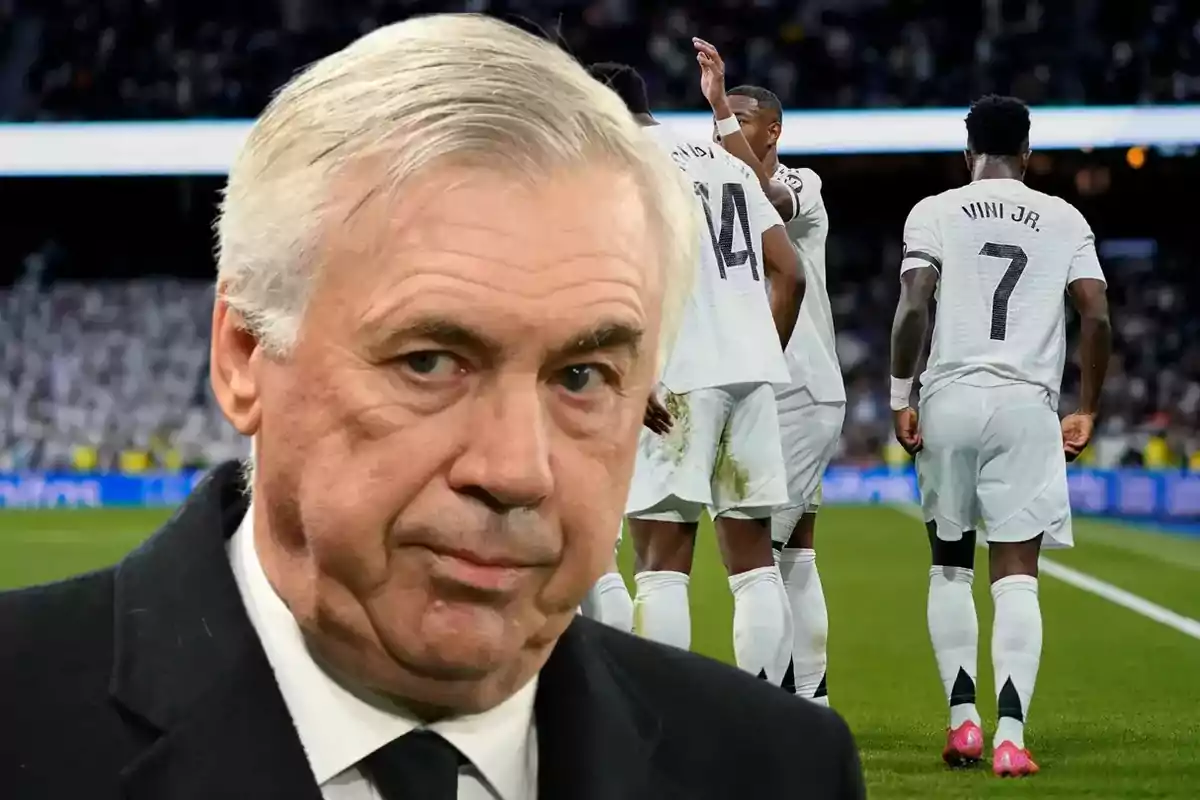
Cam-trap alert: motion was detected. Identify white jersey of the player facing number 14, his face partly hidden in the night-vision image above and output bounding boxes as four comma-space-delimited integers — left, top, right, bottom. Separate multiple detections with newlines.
774, 164, 846, 403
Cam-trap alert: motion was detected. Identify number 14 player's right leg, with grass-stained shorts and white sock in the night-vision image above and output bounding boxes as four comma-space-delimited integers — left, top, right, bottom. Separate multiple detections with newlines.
713, 385, 792, 686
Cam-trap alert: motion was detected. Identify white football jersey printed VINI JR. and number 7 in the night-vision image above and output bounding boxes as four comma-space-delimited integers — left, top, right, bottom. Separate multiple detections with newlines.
900, 179, 1104, 407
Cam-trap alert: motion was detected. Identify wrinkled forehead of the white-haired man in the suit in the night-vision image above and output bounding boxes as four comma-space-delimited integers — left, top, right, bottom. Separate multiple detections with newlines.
314, 163, 662, 347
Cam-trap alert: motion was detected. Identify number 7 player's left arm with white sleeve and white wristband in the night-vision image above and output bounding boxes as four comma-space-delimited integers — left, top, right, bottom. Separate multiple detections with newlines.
889, 199, 942, 453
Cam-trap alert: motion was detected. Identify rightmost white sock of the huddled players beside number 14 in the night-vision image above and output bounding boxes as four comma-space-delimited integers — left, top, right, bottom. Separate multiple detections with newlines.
779, 549, 829, 705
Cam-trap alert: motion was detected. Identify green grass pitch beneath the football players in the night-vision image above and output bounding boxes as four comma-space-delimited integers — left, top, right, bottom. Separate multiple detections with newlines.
0, 507, 1200, 800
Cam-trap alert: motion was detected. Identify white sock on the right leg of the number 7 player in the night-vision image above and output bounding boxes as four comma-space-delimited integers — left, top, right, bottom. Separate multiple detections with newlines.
991, 575, 1042, 747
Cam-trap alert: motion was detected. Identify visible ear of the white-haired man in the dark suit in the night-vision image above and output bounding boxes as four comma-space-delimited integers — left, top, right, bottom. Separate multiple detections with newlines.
209, 296, 263, 437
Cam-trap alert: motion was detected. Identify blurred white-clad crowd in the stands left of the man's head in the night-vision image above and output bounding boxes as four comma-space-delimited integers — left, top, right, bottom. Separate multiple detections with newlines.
0, 277, 246, 473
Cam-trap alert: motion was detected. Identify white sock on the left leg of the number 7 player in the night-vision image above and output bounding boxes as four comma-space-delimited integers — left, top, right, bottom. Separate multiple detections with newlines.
925, 566, 980, 729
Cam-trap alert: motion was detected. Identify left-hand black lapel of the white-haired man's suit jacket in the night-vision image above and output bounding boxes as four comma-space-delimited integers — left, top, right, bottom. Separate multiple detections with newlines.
110, 464, 320, 800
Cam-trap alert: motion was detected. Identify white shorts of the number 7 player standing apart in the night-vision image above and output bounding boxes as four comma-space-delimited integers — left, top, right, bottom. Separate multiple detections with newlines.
916, 383, 1074, 548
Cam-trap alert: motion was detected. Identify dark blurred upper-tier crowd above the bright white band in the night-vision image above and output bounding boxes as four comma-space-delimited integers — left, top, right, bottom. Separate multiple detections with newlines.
0, 0, 1200, 119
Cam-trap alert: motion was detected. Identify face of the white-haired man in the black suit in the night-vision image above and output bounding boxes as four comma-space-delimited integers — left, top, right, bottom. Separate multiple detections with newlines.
214, 168, 661, 710
